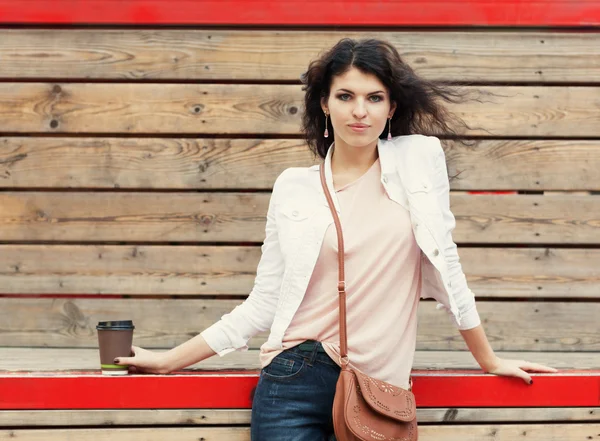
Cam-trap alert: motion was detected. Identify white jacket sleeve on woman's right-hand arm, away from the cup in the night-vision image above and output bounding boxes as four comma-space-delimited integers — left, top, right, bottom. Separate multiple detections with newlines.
430, 137, 481, 330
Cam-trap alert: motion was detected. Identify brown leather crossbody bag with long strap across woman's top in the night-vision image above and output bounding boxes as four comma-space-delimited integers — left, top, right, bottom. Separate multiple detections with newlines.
320, 164, 418, 441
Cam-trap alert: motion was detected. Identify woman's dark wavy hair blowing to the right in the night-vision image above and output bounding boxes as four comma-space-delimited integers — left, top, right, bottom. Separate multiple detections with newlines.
301, 38, 478, 175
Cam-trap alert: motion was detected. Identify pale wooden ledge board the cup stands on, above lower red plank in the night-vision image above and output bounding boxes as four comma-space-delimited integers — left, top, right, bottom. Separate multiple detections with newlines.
0, 347, 600, 372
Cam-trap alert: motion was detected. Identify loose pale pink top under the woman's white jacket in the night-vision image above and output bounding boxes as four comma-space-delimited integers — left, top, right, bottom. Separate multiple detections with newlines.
260, 159, 421, 389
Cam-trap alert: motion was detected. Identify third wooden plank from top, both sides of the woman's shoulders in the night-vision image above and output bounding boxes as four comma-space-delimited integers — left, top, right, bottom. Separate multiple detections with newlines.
0, 138, 600, 191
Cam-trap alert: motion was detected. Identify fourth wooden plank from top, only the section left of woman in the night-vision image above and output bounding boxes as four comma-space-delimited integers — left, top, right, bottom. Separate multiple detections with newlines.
0, 192, 270, 242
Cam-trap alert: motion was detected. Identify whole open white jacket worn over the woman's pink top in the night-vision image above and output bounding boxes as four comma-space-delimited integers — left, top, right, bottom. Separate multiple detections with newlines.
202, 135, 481, 356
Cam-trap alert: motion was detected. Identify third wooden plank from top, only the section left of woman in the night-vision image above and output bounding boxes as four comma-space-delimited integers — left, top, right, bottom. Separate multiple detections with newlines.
0, 137, 316, 190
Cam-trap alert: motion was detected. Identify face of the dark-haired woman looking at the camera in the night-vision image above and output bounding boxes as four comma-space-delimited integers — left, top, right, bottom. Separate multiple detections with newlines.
321, 67, 396, 147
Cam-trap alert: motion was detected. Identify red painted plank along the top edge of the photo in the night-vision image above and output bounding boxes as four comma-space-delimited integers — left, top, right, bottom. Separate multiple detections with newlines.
0, 0, 600, 26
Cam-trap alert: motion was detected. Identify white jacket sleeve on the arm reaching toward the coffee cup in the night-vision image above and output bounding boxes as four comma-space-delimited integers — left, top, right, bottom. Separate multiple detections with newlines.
201, 172, 285, 357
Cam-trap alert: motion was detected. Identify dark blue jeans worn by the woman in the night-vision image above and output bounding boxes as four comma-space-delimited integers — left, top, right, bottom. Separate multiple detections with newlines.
250, 341, 340, 441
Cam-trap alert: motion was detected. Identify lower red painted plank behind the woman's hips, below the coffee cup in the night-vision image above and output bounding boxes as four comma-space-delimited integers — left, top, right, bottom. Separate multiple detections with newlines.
0, 370, 600, 410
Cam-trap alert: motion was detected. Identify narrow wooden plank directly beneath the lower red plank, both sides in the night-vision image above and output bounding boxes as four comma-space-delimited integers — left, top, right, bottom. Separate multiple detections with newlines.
0, 407, 600, 428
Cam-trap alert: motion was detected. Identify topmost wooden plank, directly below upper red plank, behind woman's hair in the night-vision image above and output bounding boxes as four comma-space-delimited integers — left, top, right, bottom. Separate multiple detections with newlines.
0, 29, 600, 83
